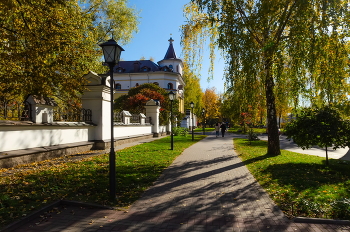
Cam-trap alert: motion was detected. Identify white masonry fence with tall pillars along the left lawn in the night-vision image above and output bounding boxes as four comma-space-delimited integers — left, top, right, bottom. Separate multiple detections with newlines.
0, 72, 170, 168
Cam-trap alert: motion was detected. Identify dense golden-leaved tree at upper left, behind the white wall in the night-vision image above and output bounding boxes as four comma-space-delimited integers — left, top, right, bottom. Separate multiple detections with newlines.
0, 0, 137, 104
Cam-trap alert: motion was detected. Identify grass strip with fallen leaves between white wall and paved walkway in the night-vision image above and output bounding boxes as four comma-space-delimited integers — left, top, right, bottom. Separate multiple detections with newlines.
0, 135, 205, 227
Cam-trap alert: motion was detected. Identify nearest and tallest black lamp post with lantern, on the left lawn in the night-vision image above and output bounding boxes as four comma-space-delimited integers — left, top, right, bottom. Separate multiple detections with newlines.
100, 39, 124, 200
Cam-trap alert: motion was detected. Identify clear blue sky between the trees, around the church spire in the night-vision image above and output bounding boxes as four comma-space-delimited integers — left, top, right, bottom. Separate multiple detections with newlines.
121, 0, 224, 93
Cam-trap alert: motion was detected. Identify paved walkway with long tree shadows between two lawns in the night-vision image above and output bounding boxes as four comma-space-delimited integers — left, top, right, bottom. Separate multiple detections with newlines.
6, 134, 349, 232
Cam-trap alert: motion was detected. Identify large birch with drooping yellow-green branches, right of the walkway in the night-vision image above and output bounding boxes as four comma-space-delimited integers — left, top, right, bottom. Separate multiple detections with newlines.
182, 0, 350, 155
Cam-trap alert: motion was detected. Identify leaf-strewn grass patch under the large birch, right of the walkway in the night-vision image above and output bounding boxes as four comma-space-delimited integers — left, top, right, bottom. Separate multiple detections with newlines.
234, 139, 350, 220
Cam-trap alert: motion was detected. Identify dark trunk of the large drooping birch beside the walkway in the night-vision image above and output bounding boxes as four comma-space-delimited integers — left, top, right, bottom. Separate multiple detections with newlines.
265, 59, 281, 155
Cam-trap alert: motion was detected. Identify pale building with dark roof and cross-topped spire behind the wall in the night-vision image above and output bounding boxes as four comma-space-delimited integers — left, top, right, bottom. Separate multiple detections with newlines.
113, 38, 185, 113
